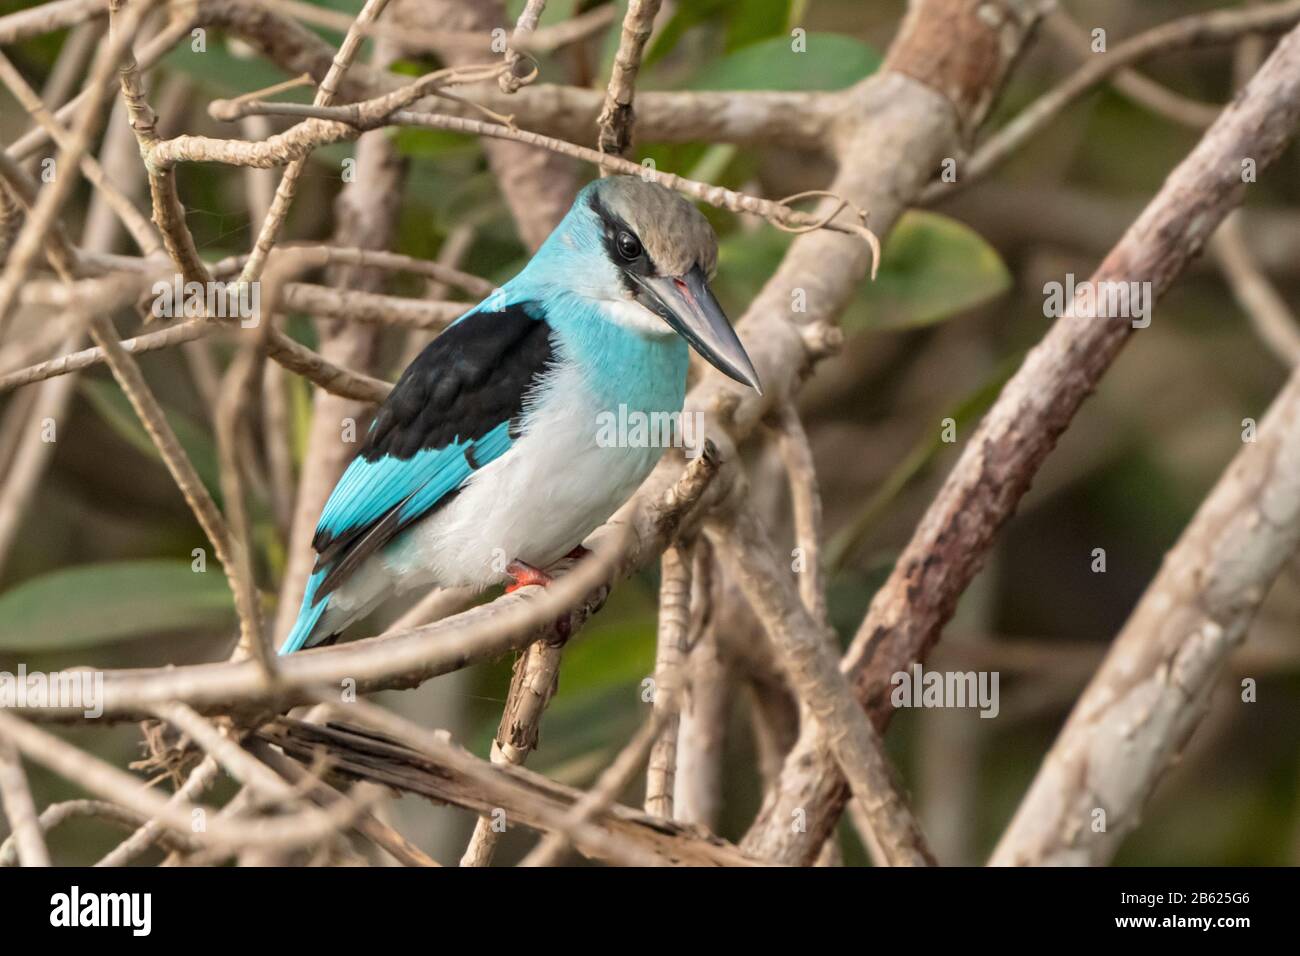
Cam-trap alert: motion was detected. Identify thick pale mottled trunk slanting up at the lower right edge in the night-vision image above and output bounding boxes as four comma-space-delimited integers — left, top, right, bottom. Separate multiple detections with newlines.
992, 361, 1300, 866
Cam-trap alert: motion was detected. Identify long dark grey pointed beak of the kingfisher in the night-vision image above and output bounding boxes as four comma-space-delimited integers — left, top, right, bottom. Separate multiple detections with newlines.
632, 265, 763, 395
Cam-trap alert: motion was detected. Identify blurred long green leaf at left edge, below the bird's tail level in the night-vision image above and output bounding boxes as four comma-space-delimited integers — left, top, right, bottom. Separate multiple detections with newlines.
0, 561, 234, 652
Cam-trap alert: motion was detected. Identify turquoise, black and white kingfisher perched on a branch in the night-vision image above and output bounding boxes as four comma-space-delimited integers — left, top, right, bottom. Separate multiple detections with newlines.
280, 176, 762, 654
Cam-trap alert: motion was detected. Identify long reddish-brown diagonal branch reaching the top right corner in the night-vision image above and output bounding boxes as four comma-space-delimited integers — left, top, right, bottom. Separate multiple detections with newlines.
745, 14, 1300, 861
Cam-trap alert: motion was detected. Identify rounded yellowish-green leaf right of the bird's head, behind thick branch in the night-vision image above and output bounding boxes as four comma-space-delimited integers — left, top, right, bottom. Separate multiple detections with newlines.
845, 209, 1011, 330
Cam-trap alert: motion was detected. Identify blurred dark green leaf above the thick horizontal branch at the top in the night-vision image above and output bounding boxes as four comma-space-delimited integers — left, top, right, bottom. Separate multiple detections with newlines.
686, 34, 880, 90
